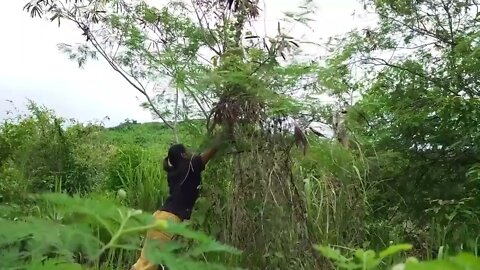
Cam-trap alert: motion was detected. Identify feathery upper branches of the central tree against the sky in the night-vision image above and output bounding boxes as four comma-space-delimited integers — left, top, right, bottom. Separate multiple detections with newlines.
25, 0, 322, 137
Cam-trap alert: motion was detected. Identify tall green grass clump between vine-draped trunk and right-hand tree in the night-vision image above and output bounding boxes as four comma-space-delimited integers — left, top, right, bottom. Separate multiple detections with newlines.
295, 138, 369, 246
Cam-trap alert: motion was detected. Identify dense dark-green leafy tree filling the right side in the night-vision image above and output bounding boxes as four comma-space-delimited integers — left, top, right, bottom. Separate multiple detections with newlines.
322, 0, 480, 253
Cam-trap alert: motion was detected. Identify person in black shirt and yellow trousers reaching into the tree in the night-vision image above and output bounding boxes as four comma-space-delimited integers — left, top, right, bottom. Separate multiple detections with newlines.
131, 138, 224, 270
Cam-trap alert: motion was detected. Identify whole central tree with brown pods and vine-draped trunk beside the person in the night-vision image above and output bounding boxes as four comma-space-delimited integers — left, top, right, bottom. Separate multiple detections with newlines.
26, 0, 326, 268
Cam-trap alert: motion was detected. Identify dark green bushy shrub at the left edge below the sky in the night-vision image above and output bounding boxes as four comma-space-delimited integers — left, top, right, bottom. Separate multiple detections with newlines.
0, 102, 104, 196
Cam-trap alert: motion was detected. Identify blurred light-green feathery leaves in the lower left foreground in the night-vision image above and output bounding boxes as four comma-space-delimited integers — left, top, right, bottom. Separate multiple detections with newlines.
0, 193, 239, 269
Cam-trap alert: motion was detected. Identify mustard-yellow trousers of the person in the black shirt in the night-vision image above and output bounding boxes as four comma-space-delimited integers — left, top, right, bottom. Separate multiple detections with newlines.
131, 211, 181, 270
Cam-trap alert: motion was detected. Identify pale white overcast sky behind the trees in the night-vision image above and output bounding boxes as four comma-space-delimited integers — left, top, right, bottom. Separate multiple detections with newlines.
0, 0, 372, 126
